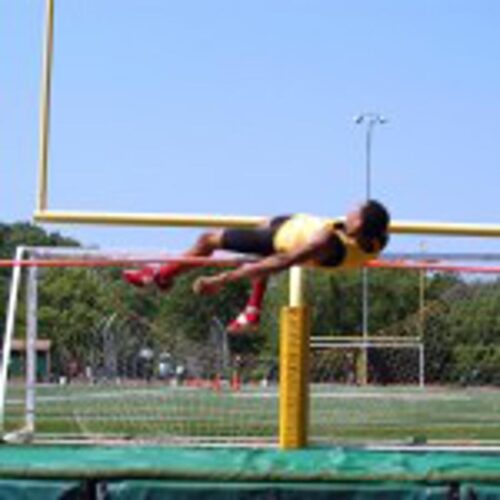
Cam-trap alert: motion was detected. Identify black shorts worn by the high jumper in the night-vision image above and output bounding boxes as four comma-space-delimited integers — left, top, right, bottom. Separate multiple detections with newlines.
222, 215, 290, 257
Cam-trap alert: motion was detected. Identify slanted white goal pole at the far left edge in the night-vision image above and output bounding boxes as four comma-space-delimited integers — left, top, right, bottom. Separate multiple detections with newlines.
0, 246, 24, 432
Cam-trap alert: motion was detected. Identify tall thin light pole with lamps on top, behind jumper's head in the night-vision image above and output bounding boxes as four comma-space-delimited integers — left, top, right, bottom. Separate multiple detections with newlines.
354, 113, 387, 384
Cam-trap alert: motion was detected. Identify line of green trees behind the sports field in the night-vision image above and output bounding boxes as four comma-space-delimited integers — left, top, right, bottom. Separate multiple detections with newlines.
0, 222, 500, 385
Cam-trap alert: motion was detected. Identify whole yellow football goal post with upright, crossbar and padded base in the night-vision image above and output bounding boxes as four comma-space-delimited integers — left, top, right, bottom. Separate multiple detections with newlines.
30, 0, 500, 448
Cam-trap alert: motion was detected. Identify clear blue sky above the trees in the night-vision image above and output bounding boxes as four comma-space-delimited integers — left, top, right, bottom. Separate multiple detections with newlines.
0, 0, 500, 251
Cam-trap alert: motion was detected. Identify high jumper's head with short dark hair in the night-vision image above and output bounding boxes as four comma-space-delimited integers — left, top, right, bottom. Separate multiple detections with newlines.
346, 200, 390, 251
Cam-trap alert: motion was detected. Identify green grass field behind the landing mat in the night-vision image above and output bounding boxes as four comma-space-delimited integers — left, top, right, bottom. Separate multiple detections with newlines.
6, 383, 500, 444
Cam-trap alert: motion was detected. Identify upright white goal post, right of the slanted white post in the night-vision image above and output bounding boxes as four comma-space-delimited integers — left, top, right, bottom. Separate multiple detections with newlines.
26, 256, 38, 432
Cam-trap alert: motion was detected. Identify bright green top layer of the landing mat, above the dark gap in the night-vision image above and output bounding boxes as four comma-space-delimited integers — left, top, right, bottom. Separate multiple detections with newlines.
0, 445, 500, 483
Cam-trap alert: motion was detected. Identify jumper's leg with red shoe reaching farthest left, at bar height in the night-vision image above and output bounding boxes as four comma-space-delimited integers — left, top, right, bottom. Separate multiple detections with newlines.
123, 231, 222, 290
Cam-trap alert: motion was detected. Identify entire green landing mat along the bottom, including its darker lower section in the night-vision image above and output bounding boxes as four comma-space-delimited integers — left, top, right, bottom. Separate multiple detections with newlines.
0, 445, 500, 500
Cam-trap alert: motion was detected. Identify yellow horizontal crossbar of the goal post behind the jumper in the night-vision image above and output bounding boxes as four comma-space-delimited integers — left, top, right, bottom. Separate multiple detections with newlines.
33, 210, 500, 238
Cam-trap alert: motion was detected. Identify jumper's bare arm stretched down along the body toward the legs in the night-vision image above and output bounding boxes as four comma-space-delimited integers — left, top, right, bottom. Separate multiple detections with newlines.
193, 230, 331, 294
